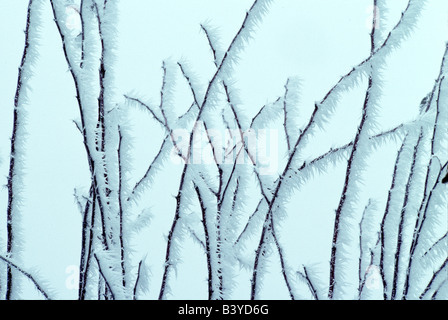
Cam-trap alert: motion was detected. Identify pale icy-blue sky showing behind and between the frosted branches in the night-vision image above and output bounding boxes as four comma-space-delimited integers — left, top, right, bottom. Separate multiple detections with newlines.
0, 0, 448, 299
